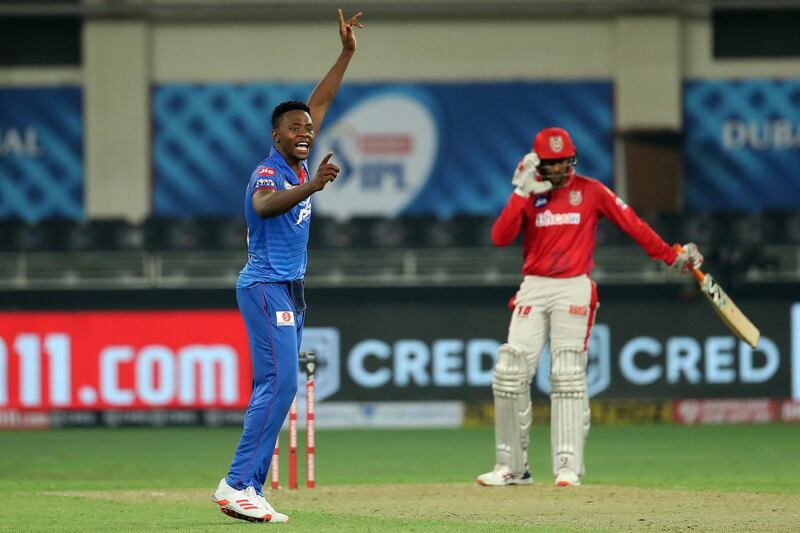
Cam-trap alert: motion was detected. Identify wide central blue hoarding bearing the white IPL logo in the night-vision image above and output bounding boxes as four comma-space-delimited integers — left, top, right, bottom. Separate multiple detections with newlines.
153, 81, 613, 218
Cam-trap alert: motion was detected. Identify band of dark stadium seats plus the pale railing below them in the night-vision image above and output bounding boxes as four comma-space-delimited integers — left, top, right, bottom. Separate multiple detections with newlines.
0, 211, 800, 287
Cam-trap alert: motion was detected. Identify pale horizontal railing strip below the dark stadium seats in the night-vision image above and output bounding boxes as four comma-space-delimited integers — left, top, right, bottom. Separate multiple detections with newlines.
0, 246, 800, 290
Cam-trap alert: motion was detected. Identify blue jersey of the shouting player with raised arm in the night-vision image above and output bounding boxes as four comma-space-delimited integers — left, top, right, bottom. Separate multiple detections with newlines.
236, 147, 311, 288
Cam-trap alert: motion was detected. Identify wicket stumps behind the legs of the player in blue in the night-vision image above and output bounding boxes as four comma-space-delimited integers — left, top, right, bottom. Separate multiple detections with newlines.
270, 352, 317, 490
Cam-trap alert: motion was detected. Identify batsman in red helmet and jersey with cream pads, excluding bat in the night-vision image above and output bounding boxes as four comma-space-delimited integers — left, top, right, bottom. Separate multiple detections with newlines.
478, 128, 703, 487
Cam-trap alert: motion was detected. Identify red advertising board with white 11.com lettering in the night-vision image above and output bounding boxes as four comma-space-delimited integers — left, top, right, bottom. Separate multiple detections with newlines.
0, 310, 252, 411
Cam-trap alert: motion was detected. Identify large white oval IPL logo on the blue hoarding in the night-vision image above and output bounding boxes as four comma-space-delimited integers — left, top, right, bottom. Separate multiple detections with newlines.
311, 90, 439, 218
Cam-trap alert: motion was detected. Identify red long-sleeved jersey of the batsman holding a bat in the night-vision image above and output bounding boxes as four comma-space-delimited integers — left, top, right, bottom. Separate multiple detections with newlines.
492, 175, 677, 278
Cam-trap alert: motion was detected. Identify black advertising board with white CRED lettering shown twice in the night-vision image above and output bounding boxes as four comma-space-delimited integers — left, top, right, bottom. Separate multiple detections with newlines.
310, 298, 800, 401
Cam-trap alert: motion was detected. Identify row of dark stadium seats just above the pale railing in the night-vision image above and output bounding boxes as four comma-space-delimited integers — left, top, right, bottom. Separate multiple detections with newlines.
0, 211, 800, 252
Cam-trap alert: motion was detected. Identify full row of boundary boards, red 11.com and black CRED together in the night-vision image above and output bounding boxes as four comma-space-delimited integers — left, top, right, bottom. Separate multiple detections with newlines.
0, 301, 800, 411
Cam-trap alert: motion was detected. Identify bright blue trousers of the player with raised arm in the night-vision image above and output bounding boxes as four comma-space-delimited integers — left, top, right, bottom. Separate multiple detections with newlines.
226, 281, 305, 494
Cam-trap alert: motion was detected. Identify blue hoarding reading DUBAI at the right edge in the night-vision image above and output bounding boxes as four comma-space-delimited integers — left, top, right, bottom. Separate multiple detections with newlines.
684, 79, 800, 211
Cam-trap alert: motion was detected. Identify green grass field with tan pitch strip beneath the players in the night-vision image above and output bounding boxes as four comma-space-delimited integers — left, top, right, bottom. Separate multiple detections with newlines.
0, 425, 800, 532
